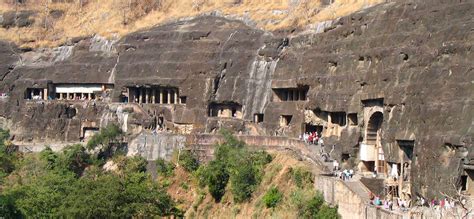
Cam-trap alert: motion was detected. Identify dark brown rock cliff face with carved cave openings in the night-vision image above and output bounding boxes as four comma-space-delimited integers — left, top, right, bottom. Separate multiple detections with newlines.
0, 2, 474, 197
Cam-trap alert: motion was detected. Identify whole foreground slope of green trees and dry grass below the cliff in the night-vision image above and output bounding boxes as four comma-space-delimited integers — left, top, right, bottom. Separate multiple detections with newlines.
0, 126, 339, 218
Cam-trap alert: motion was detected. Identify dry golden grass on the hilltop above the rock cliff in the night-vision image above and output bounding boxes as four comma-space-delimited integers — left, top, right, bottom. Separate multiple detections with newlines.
0, 0, 382, 47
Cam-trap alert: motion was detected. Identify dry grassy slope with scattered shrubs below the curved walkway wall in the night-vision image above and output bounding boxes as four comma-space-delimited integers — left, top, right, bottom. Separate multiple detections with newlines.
167, 152, 330, 218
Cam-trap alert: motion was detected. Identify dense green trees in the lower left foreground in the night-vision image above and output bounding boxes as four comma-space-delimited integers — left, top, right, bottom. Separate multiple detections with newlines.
0, 126, 181, 218
